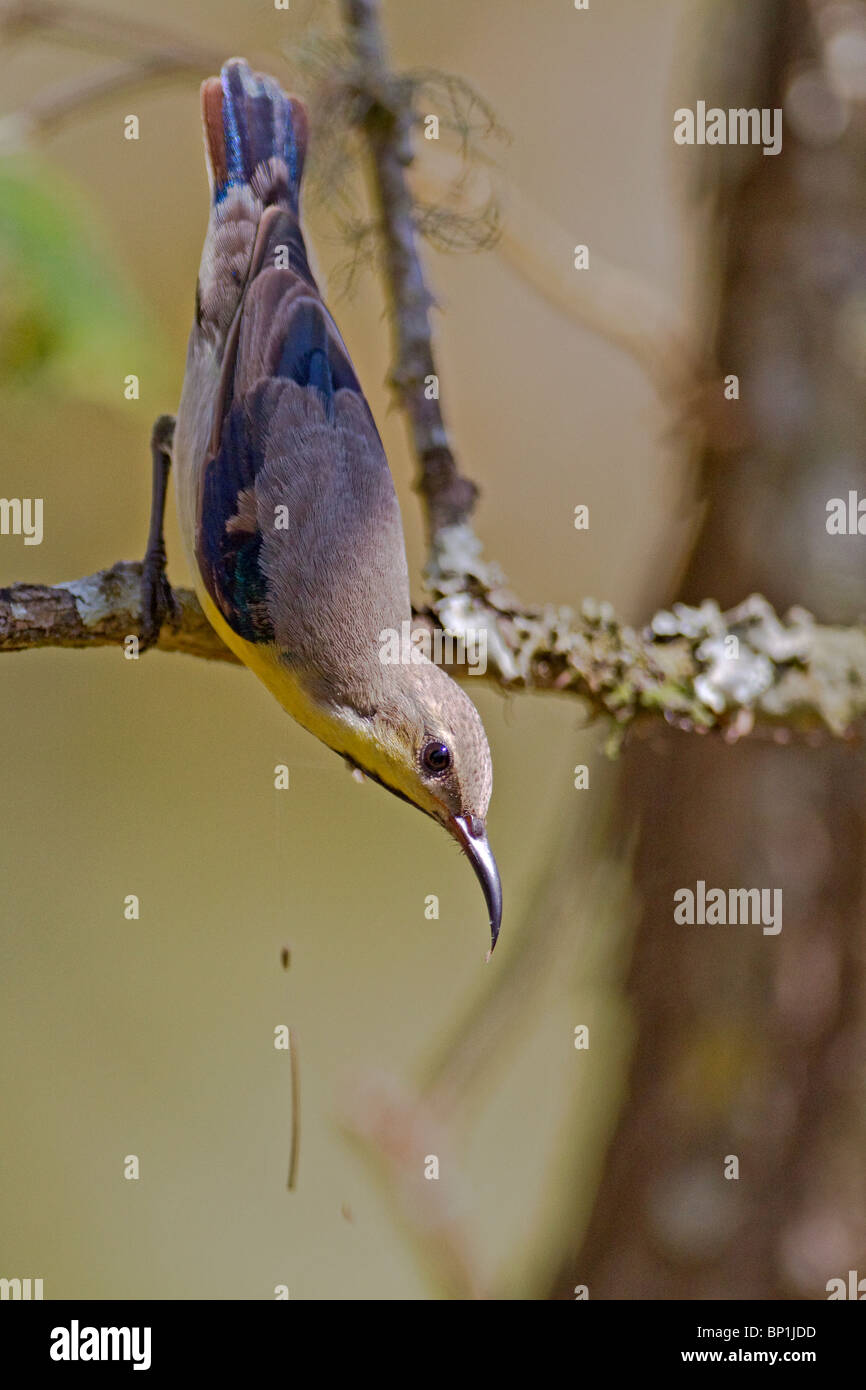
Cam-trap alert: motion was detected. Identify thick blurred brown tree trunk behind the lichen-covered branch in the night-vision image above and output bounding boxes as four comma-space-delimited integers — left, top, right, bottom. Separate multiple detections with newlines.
553, 0, 866, 1300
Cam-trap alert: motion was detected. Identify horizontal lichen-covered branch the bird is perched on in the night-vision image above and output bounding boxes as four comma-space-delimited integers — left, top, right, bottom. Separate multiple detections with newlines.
0, 562, 866, 742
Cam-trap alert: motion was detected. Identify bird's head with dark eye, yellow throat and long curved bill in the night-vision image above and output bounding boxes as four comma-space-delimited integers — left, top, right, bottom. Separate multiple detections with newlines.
326, 659, 502, 951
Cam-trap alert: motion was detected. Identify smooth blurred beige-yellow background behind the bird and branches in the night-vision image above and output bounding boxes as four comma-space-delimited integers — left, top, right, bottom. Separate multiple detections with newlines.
0, 0, 694, 1300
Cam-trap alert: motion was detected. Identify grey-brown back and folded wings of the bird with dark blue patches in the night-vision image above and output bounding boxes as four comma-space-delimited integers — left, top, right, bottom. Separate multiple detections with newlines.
196, 209, 410, 686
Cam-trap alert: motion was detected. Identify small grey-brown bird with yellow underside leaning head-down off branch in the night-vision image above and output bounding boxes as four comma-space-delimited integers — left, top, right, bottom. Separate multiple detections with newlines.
142, 58, 502, 959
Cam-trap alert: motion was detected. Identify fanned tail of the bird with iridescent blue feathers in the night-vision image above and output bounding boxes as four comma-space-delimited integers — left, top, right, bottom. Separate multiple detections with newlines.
202, 58, 307, 213
